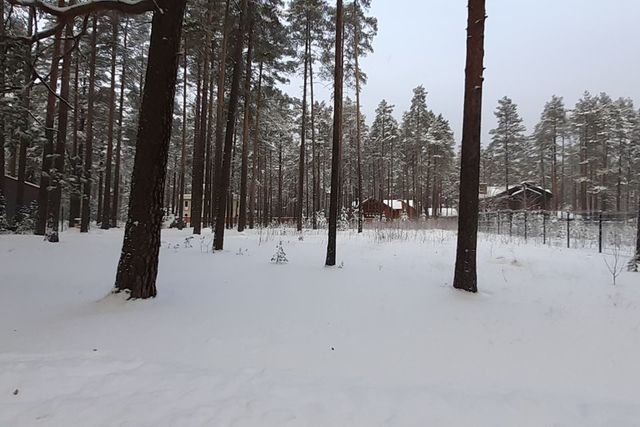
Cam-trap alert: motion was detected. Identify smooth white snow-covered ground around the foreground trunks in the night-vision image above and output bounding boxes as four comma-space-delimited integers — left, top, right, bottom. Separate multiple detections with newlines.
0, 226, 640, 427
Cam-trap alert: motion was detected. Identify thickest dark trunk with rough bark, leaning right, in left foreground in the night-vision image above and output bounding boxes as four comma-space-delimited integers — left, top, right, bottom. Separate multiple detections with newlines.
115, 0, 186, 298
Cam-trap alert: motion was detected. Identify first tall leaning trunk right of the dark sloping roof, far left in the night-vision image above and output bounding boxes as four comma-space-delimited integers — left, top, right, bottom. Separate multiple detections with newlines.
35, 12, 64, 236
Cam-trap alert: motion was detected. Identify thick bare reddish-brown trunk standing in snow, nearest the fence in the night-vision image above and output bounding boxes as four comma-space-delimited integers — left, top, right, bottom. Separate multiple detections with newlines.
453, 0, 486, 292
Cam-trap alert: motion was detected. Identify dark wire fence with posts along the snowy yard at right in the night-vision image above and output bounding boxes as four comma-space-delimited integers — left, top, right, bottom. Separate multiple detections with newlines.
479, 211, 637, 255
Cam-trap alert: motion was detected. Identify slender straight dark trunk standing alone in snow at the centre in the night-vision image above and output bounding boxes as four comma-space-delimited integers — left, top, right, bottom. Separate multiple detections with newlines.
325, 0, 344, 266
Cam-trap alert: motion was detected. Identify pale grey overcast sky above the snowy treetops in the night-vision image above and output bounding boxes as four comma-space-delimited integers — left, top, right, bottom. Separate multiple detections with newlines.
289, 0, 640, 143
